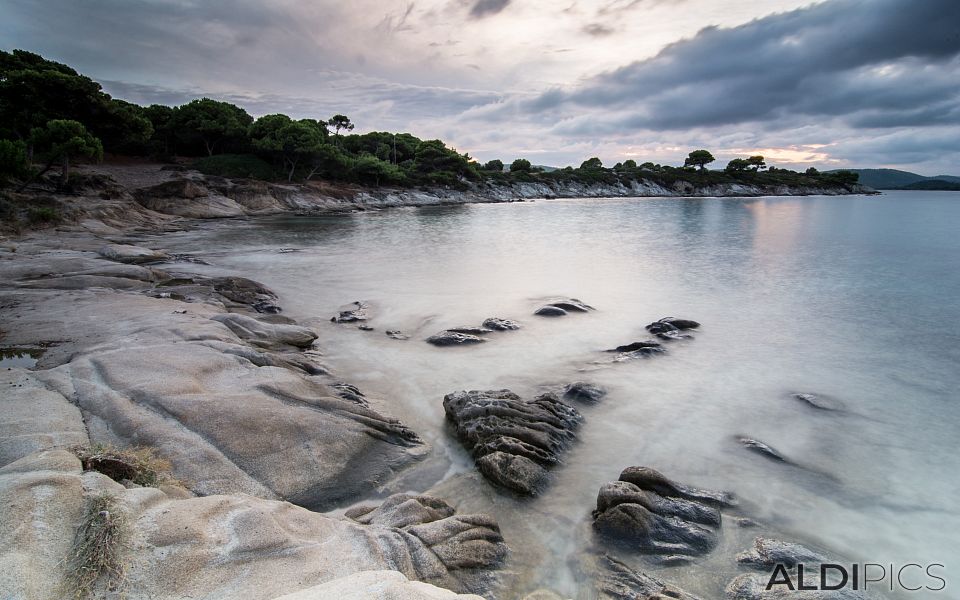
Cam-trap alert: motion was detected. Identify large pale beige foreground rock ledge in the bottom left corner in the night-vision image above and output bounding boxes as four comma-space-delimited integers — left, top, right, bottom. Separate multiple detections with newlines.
0, 450, 507, 600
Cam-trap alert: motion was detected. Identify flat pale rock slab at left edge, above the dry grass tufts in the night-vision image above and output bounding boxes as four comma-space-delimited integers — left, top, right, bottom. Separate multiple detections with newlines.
0, 369, 90, 467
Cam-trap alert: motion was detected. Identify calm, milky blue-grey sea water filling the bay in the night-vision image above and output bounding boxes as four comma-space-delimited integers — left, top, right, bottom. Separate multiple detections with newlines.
154, 192, 960, 597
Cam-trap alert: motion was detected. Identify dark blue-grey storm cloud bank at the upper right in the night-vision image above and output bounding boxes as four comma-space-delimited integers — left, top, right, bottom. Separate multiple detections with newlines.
532, 0, 960, 133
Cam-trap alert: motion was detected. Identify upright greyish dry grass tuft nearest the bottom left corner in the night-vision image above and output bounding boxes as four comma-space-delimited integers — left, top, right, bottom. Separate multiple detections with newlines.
68, 493, 128, 599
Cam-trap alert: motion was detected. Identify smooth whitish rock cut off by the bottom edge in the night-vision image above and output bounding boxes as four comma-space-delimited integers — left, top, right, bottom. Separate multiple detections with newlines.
273, 571, 492, 600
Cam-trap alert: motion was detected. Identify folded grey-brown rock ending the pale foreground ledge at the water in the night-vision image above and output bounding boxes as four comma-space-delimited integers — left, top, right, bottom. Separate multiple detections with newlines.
345, 494, 508, 591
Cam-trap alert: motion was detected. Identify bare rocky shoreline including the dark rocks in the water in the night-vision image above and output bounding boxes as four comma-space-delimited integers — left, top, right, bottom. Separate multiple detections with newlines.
0, 171, 884, 600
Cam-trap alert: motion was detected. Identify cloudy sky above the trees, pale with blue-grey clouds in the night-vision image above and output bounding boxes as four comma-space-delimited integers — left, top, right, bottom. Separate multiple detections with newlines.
0, 0, 960, 175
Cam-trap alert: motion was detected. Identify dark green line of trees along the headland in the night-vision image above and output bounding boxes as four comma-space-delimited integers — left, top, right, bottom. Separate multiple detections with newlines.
0, 50, 856, 188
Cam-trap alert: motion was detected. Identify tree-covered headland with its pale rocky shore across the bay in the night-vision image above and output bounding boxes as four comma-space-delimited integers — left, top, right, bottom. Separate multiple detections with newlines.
0, 50, 872, 228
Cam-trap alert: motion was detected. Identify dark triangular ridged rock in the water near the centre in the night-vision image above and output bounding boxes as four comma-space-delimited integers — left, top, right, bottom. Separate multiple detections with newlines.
443, 390, 582, 495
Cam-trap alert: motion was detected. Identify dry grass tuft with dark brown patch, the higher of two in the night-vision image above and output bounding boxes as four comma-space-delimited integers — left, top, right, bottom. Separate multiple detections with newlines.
74, 444, 180, 487
